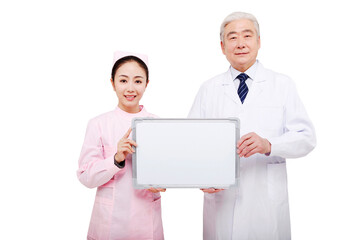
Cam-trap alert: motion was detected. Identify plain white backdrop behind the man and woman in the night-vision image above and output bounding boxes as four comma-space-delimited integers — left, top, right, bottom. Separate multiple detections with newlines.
0, 0, 360, 240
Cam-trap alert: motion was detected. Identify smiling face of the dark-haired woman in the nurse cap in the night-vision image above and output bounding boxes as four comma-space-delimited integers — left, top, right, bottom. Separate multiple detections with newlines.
111, 61, 147, 113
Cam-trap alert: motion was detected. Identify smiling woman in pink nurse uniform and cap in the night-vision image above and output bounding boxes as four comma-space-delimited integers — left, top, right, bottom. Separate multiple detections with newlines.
77, 52, 165, 240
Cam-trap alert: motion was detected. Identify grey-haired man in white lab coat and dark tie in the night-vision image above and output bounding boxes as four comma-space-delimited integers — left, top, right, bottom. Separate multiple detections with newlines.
189, 12, 316, 240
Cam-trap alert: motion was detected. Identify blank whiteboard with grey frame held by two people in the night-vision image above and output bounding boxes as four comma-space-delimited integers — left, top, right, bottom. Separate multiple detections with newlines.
132, 118, 240, 188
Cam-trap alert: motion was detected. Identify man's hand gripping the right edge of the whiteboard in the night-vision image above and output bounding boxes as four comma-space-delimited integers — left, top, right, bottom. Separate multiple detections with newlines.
236, 132, 271, 157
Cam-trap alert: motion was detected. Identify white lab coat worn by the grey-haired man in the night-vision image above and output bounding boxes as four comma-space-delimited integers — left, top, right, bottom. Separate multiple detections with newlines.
188, 63, 316, 240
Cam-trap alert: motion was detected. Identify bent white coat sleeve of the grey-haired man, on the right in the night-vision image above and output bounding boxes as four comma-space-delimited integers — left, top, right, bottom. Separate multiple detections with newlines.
268, 81, 316, 158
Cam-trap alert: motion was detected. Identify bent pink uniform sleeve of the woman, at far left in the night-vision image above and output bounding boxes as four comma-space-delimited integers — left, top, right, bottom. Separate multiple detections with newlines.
77, 119, 123, 188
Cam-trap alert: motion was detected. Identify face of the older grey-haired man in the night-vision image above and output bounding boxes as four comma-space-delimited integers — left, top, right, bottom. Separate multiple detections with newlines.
221, 19, 260, 72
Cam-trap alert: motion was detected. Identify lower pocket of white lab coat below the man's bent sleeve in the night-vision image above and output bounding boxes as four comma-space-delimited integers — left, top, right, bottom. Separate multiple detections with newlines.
267, 162, 287, 204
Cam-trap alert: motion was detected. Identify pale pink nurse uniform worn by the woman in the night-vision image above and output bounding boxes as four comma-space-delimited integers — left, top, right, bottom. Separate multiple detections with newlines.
77, 106, 164, 240
